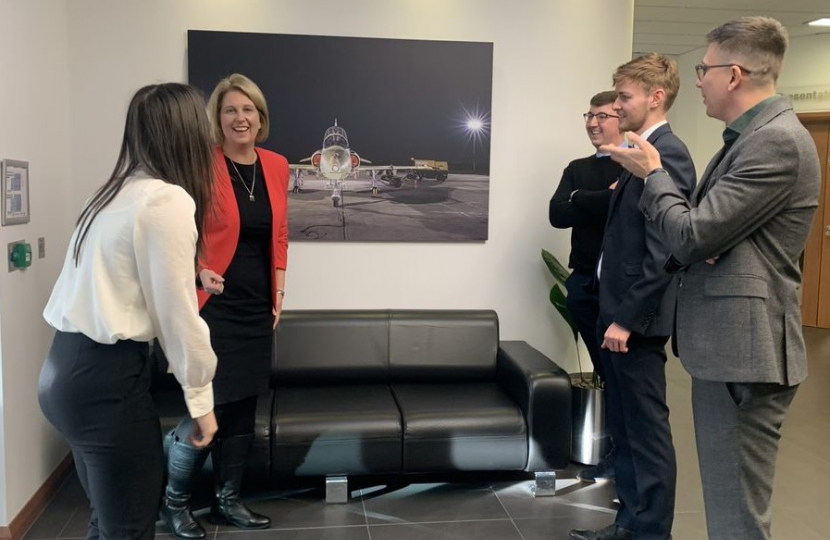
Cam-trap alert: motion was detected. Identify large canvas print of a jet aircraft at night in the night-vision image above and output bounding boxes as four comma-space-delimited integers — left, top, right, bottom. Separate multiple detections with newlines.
187, 30, 498, 242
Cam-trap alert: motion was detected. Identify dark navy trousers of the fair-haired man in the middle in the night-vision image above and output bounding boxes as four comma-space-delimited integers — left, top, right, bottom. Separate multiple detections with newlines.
598, 324, 677, 540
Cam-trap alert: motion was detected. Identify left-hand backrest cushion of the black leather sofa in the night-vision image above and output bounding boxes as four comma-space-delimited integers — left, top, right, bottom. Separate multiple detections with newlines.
271, 310, 389, 385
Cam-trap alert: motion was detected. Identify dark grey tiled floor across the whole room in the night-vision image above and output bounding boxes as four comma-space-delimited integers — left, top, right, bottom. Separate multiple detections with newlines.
19, 329, 830, 540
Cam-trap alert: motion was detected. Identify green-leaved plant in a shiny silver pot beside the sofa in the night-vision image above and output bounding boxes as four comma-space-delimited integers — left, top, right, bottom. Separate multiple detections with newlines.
542, 249, 610, 465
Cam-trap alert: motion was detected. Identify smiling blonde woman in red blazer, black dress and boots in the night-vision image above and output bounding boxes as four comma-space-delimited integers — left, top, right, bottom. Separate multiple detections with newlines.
161, 74, 288, 538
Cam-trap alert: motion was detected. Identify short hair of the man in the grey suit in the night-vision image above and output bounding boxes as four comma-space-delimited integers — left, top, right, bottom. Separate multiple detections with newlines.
706, 16, 789, 83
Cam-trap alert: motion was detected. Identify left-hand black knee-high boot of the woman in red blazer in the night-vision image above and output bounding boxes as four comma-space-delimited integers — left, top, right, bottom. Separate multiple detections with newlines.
161, 431, 211, 539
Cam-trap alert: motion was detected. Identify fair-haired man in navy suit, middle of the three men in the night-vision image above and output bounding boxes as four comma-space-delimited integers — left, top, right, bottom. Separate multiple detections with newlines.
570, 54, 695, 540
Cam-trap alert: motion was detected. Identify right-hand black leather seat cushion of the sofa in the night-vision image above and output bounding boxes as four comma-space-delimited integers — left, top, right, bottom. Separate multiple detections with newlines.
392, 383, 527, 473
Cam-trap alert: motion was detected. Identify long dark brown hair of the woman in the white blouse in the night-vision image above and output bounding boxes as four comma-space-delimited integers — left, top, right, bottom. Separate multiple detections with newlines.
73, 83, 213, 265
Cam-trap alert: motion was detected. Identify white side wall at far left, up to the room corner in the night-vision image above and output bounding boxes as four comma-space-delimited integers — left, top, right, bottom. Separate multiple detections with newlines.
0, 0, 73, 526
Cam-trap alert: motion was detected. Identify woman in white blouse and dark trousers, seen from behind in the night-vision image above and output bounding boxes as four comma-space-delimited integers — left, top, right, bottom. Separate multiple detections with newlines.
38, 83, 218, 539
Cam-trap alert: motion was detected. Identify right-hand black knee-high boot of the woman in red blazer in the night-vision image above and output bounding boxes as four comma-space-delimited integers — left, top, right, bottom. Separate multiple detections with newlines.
210, 434, 271, 529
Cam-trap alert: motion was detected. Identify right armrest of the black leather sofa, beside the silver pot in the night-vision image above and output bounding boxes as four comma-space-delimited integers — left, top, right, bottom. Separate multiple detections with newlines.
496, 341, 571, 472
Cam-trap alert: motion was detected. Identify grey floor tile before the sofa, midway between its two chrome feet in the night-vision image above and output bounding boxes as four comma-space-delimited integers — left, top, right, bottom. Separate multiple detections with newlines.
363, 483, 508, 524
